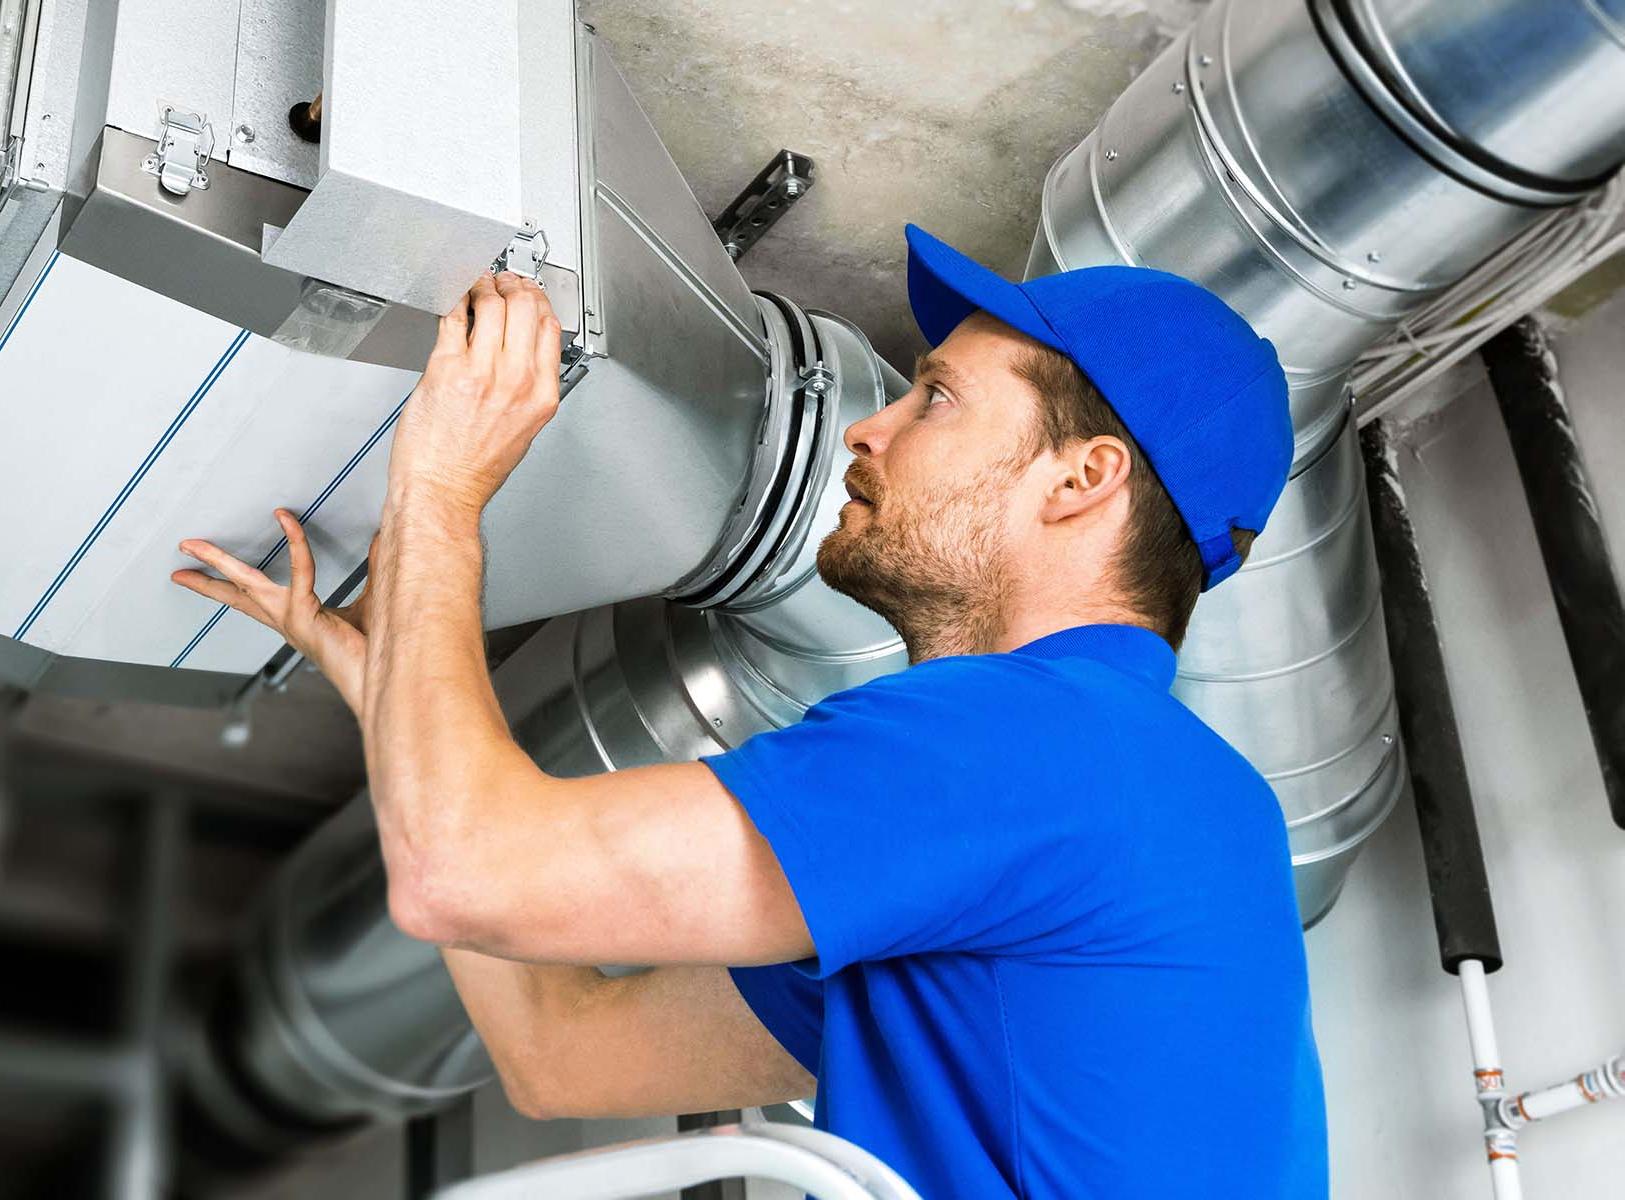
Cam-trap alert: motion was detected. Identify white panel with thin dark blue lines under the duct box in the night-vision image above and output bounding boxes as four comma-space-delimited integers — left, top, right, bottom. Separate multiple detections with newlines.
0, 254, 416, 673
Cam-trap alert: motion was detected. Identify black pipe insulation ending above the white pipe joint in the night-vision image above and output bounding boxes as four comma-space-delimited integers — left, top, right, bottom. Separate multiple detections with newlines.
1360, 421, 1502, 974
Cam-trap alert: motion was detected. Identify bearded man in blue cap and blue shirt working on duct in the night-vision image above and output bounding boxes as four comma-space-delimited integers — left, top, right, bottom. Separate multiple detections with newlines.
176, 226, 1326, 1200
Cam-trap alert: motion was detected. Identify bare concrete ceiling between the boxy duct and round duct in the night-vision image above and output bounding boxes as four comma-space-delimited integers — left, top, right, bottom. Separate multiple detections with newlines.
580, 0, 1201, 366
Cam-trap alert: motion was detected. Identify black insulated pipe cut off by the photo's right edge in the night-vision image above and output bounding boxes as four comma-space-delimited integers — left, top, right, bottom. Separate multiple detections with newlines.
1479, 317, 1625, 829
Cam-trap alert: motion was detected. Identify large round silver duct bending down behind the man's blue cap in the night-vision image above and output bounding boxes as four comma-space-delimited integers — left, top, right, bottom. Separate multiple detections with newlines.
1027, 0, 1625, 925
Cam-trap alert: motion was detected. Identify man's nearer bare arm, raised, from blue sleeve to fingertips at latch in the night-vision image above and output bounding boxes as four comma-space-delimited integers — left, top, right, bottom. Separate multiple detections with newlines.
362, 276, 813, 964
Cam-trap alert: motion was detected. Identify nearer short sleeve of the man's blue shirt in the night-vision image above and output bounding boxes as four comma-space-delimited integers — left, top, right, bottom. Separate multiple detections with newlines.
705, 655, 1113, 977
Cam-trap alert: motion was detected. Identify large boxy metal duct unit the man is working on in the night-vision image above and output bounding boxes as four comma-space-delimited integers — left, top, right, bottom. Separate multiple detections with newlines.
0, 0, 840, 701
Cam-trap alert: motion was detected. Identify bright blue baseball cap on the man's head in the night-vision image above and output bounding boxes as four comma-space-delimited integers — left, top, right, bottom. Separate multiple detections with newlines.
907, 224, 1292, 592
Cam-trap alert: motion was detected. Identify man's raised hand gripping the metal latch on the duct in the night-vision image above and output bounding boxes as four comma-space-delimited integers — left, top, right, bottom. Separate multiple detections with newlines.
390, 272, 561, 514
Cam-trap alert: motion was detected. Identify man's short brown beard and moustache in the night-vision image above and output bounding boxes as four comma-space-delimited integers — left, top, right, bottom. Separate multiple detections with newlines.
817, 459, 1014, 662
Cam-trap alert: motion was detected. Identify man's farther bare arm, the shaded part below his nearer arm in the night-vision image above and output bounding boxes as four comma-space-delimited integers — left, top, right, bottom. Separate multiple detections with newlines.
445, 950, 813, 1119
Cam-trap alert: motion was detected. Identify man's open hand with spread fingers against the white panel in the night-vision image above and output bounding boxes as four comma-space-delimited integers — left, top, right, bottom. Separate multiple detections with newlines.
171, 509, 377, 715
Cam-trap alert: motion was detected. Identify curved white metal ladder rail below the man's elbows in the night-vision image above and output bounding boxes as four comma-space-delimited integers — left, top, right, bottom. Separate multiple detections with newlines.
437, 1122, 920, 1200
